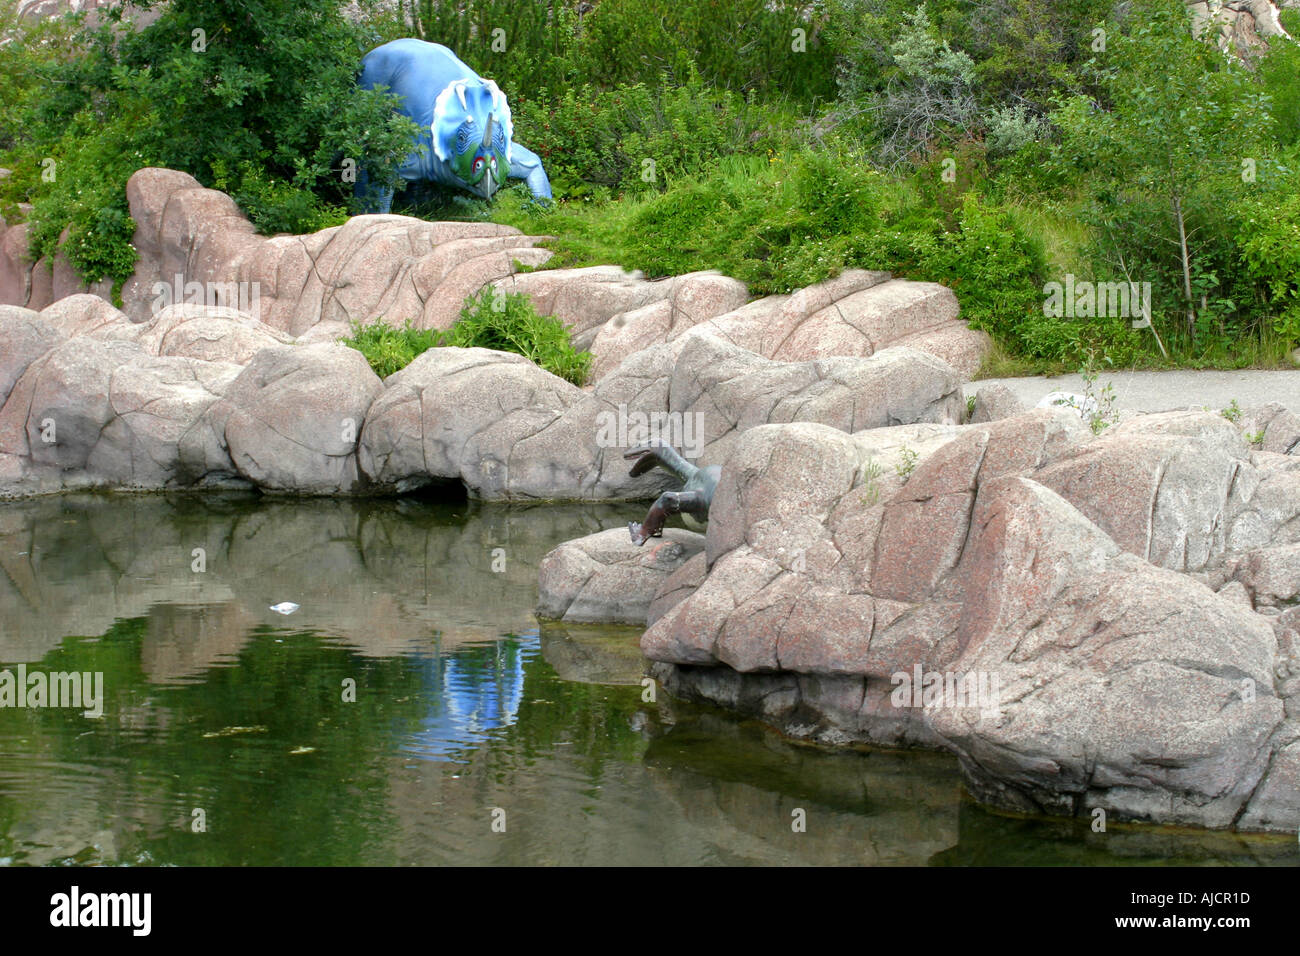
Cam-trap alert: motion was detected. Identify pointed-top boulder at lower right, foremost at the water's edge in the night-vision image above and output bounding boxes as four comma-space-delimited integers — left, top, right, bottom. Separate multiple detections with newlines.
931, 477, 1282, 826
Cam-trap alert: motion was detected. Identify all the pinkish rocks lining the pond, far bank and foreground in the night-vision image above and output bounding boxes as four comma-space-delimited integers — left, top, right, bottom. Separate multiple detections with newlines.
0, 169, 1300, 831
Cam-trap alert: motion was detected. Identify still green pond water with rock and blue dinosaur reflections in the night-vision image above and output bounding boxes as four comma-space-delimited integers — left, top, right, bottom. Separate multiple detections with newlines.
0, 496, 1297, 865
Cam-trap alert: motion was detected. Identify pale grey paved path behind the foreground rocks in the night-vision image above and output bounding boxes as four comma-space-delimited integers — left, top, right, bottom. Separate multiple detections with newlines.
963, 368, 1300, 411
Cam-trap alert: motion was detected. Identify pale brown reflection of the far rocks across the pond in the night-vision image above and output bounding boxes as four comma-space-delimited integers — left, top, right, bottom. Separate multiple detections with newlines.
0, 494, 621, 682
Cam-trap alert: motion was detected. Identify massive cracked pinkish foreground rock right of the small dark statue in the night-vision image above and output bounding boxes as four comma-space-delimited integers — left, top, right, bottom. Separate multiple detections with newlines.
641, 410, 1300, 829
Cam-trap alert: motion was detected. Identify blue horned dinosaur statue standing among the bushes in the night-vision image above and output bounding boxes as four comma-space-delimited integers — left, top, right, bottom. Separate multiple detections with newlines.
356, 39, 551, 212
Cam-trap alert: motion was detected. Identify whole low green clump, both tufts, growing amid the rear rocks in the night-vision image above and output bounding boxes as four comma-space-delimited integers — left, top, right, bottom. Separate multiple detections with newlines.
341, 289, 592, 385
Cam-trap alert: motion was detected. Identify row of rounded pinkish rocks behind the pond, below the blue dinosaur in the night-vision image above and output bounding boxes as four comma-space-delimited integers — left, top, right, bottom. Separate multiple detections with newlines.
0, 169, 988, 499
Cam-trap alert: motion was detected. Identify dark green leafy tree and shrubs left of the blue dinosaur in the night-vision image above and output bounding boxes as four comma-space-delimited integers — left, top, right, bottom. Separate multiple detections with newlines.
0, 0, 412, 282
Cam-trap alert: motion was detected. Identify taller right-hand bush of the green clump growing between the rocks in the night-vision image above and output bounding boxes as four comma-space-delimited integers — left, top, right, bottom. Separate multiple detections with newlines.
439, 289, 592, 385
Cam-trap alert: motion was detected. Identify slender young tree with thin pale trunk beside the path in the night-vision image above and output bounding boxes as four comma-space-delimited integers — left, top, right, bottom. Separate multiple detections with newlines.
1056, 0, 1274, 350
